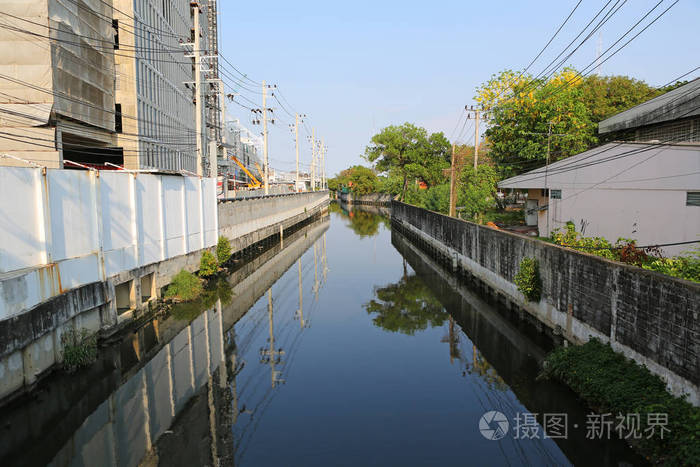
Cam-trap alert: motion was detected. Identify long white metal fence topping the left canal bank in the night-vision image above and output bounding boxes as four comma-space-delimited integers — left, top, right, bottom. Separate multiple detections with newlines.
0, 167, 217, 320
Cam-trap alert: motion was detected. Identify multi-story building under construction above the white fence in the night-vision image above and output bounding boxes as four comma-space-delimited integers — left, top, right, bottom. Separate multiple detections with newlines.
0, 0, 222, 175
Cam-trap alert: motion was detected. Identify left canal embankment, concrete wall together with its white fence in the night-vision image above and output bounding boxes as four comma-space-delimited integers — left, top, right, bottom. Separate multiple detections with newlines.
0, 167, 328, 399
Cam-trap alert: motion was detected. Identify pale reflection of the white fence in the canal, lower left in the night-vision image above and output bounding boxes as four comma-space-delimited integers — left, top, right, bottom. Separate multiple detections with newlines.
47, 304, 224, 465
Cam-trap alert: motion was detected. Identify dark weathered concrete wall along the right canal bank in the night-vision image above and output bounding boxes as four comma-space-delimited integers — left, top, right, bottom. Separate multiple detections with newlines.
392, 201, 700, 405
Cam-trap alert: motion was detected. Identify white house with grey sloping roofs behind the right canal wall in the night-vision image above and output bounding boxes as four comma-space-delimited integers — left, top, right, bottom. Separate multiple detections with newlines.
498, 79, 700, 255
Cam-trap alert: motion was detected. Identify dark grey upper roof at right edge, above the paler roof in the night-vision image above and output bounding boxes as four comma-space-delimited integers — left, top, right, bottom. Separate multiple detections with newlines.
598, 78, 700, 134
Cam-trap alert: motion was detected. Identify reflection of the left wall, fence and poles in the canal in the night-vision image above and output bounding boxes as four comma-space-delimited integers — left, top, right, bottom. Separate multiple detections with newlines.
0, 218, 328, 466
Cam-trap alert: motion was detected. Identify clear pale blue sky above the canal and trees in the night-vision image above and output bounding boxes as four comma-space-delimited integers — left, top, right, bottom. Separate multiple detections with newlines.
219, 0, 700, 176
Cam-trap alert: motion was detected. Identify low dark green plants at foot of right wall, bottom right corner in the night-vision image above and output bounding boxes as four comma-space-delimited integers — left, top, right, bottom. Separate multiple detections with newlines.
543, 339, 700, 465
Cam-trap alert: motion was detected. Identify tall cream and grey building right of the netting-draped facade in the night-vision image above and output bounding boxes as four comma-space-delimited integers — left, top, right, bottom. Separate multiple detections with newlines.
114, 0, 218, 173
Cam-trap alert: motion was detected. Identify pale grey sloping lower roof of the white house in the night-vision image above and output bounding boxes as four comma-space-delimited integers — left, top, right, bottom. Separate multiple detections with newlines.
498, 143, 700, 191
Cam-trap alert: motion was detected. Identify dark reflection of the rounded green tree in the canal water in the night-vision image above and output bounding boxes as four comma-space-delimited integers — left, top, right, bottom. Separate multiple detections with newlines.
365, 274, 449, 335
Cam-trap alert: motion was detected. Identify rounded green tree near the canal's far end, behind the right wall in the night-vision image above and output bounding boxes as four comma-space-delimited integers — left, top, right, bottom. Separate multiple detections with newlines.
365, 123, 450, 200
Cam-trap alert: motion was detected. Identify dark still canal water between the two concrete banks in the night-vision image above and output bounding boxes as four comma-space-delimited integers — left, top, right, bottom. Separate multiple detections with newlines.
0, 205, 643, 467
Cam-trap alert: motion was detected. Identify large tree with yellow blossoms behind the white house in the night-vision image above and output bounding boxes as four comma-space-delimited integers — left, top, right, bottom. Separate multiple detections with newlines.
475, 68, 661, 176
